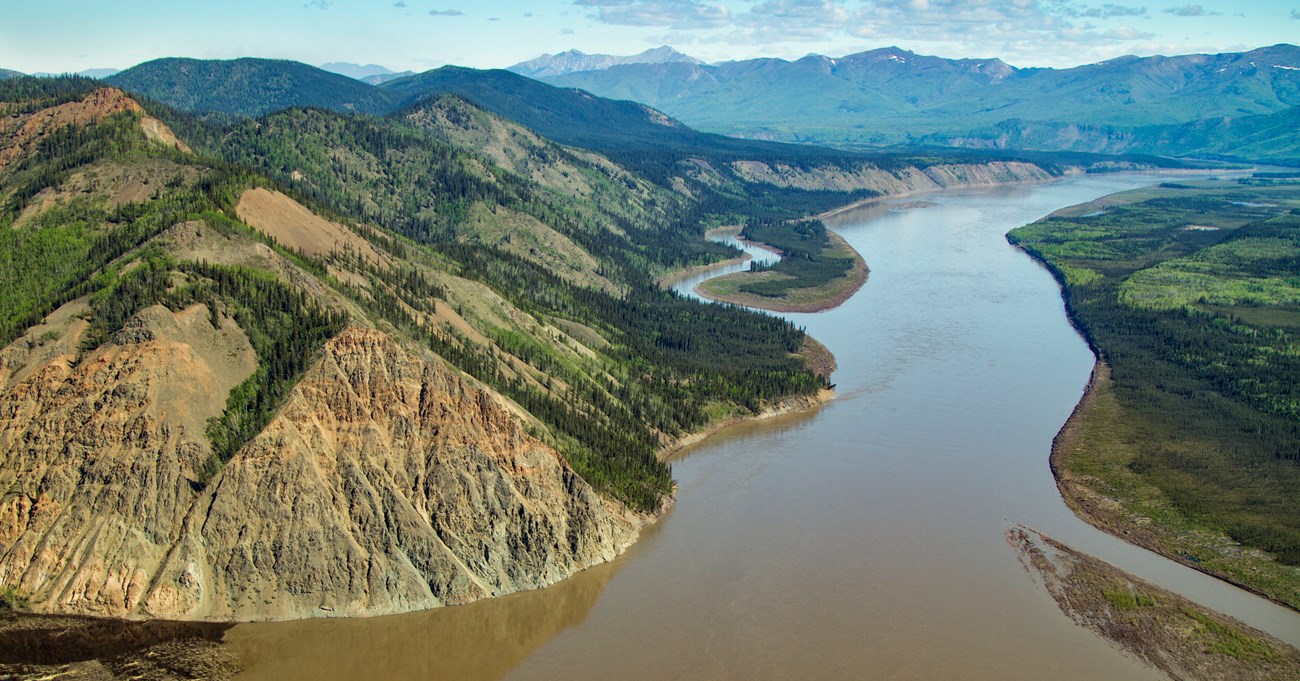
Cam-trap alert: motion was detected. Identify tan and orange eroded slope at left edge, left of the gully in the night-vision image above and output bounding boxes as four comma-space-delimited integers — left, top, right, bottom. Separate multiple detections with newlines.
0, 305, 256, 615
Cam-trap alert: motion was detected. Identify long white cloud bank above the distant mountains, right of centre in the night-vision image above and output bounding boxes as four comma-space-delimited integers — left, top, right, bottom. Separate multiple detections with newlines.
572, 0, 1248, 66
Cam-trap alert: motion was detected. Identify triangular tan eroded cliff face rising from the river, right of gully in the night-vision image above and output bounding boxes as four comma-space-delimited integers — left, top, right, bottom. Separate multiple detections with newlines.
146, 326, 642, 619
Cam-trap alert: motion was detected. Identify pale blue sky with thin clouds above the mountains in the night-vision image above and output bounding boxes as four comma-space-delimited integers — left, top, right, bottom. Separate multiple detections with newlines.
0, 0, 1300, 73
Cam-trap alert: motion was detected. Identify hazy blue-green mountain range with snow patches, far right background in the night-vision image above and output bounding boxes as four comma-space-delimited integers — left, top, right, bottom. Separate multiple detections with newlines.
542, 44, 1300, 157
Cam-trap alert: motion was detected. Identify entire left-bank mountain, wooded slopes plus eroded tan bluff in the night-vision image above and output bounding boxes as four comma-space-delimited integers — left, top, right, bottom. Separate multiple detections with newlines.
0, 71, 842, 620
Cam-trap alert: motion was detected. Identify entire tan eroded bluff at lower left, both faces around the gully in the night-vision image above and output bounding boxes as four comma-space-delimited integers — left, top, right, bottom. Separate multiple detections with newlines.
0, 305, 646, 620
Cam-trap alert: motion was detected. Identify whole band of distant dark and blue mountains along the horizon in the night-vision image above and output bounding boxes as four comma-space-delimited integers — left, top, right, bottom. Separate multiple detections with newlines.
94, 45, 1300, 165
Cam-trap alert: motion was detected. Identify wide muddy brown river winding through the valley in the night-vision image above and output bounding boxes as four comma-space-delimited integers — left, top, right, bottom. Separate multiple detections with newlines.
226, 175, 1300, 680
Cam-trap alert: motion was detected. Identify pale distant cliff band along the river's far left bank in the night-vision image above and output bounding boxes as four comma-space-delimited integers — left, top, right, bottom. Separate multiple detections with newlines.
732, 161, 1052, 196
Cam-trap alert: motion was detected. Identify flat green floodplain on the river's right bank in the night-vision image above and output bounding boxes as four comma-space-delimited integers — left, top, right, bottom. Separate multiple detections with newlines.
1009, 182, 1300, 607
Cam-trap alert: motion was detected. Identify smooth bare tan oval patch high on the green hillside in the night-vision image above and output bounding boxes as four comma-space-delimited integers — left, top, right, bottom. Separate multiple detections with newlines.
235, 187, 382, 264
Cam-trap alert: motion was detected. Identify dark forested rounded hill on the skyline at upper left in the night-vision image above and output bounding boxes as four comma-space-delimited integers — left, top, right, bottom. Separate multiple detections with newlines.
105, 58, 390, 116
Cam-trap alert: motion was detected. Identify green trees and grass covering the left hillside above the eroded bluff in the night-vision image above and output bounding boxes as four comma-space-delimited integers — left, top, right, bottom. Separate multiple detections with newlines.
0, 79, 828, 511
